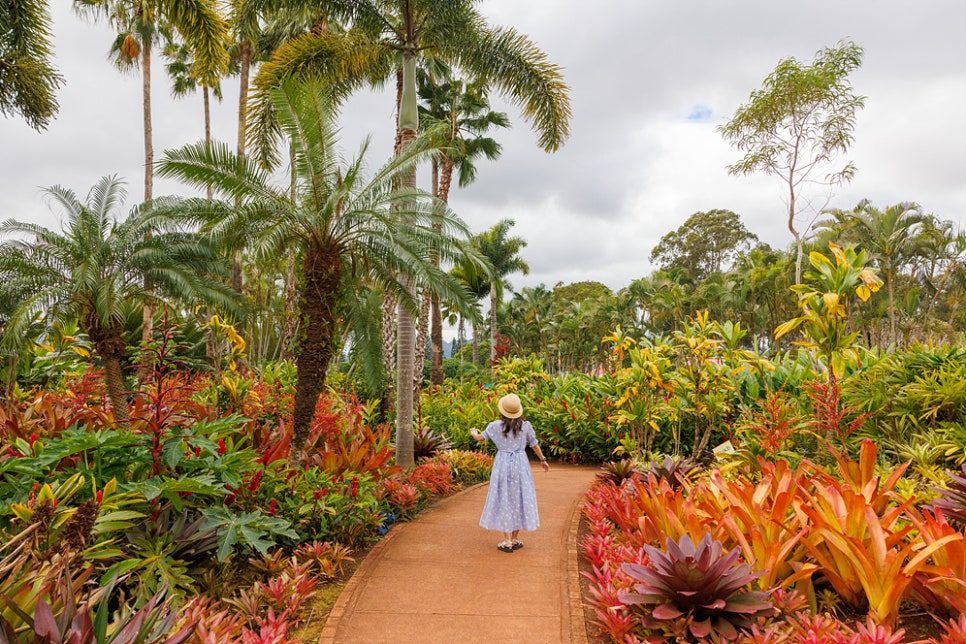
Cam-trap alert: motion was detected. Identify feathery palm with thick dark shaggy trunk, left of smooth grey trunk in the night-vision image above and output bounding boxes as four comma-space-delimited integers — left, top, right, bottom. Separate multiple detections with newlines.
158, 80, 482, 462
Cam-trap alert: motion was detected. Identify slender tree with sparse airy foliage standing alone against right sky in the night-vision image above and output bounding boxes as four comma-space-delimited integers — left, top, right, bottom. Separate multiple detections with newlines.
718, 42, 865, 284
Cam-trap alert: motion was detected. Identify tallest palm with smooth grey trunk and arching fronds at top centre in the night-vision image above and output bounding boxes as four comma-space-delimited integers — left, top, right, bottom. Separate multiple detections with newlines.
246, 0, 570, 465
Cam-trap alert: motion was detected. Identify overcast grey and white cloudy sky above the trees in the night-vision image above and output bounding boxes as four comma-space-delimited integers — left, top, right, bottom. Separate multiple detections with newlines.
0, 0, 966, 289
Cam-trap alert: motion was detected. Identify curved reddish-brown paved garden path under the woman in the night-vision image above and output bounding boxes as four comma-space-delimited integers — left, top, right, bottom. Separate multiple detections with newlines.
319, 463, 599, 644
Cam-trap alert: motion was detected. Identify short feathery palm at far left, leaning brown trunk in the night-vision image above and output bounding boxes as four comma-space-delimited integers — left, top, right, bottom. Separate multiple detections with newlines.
0, 177, 234, 420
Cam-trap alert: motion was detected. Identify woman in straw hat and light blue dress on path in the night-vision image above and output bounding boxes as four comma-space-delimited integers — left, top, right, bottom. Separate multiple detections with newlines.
470, 394, 550, 552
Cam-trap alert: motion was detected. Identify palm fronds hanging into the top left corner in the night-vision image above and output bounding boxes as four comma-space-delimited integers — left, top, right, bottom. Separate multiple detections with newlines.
0, 0, 64, 130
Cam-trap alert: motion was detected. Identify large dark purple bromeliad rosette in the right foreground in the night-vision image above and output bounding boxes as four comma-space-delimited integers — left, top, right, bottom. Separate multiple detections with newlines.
618, 534, 775, 641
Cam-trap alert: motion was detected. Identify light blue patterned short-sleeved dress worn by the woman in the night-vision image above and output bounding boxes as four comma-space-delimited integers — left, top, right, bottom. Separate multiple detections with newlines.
480, 420, 540, 532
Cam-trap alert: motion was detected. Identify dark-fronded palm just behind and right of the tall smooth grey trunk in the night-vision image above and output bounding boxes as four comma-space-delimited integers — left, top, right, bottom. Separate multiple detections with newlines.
416, 72, 510, 385
